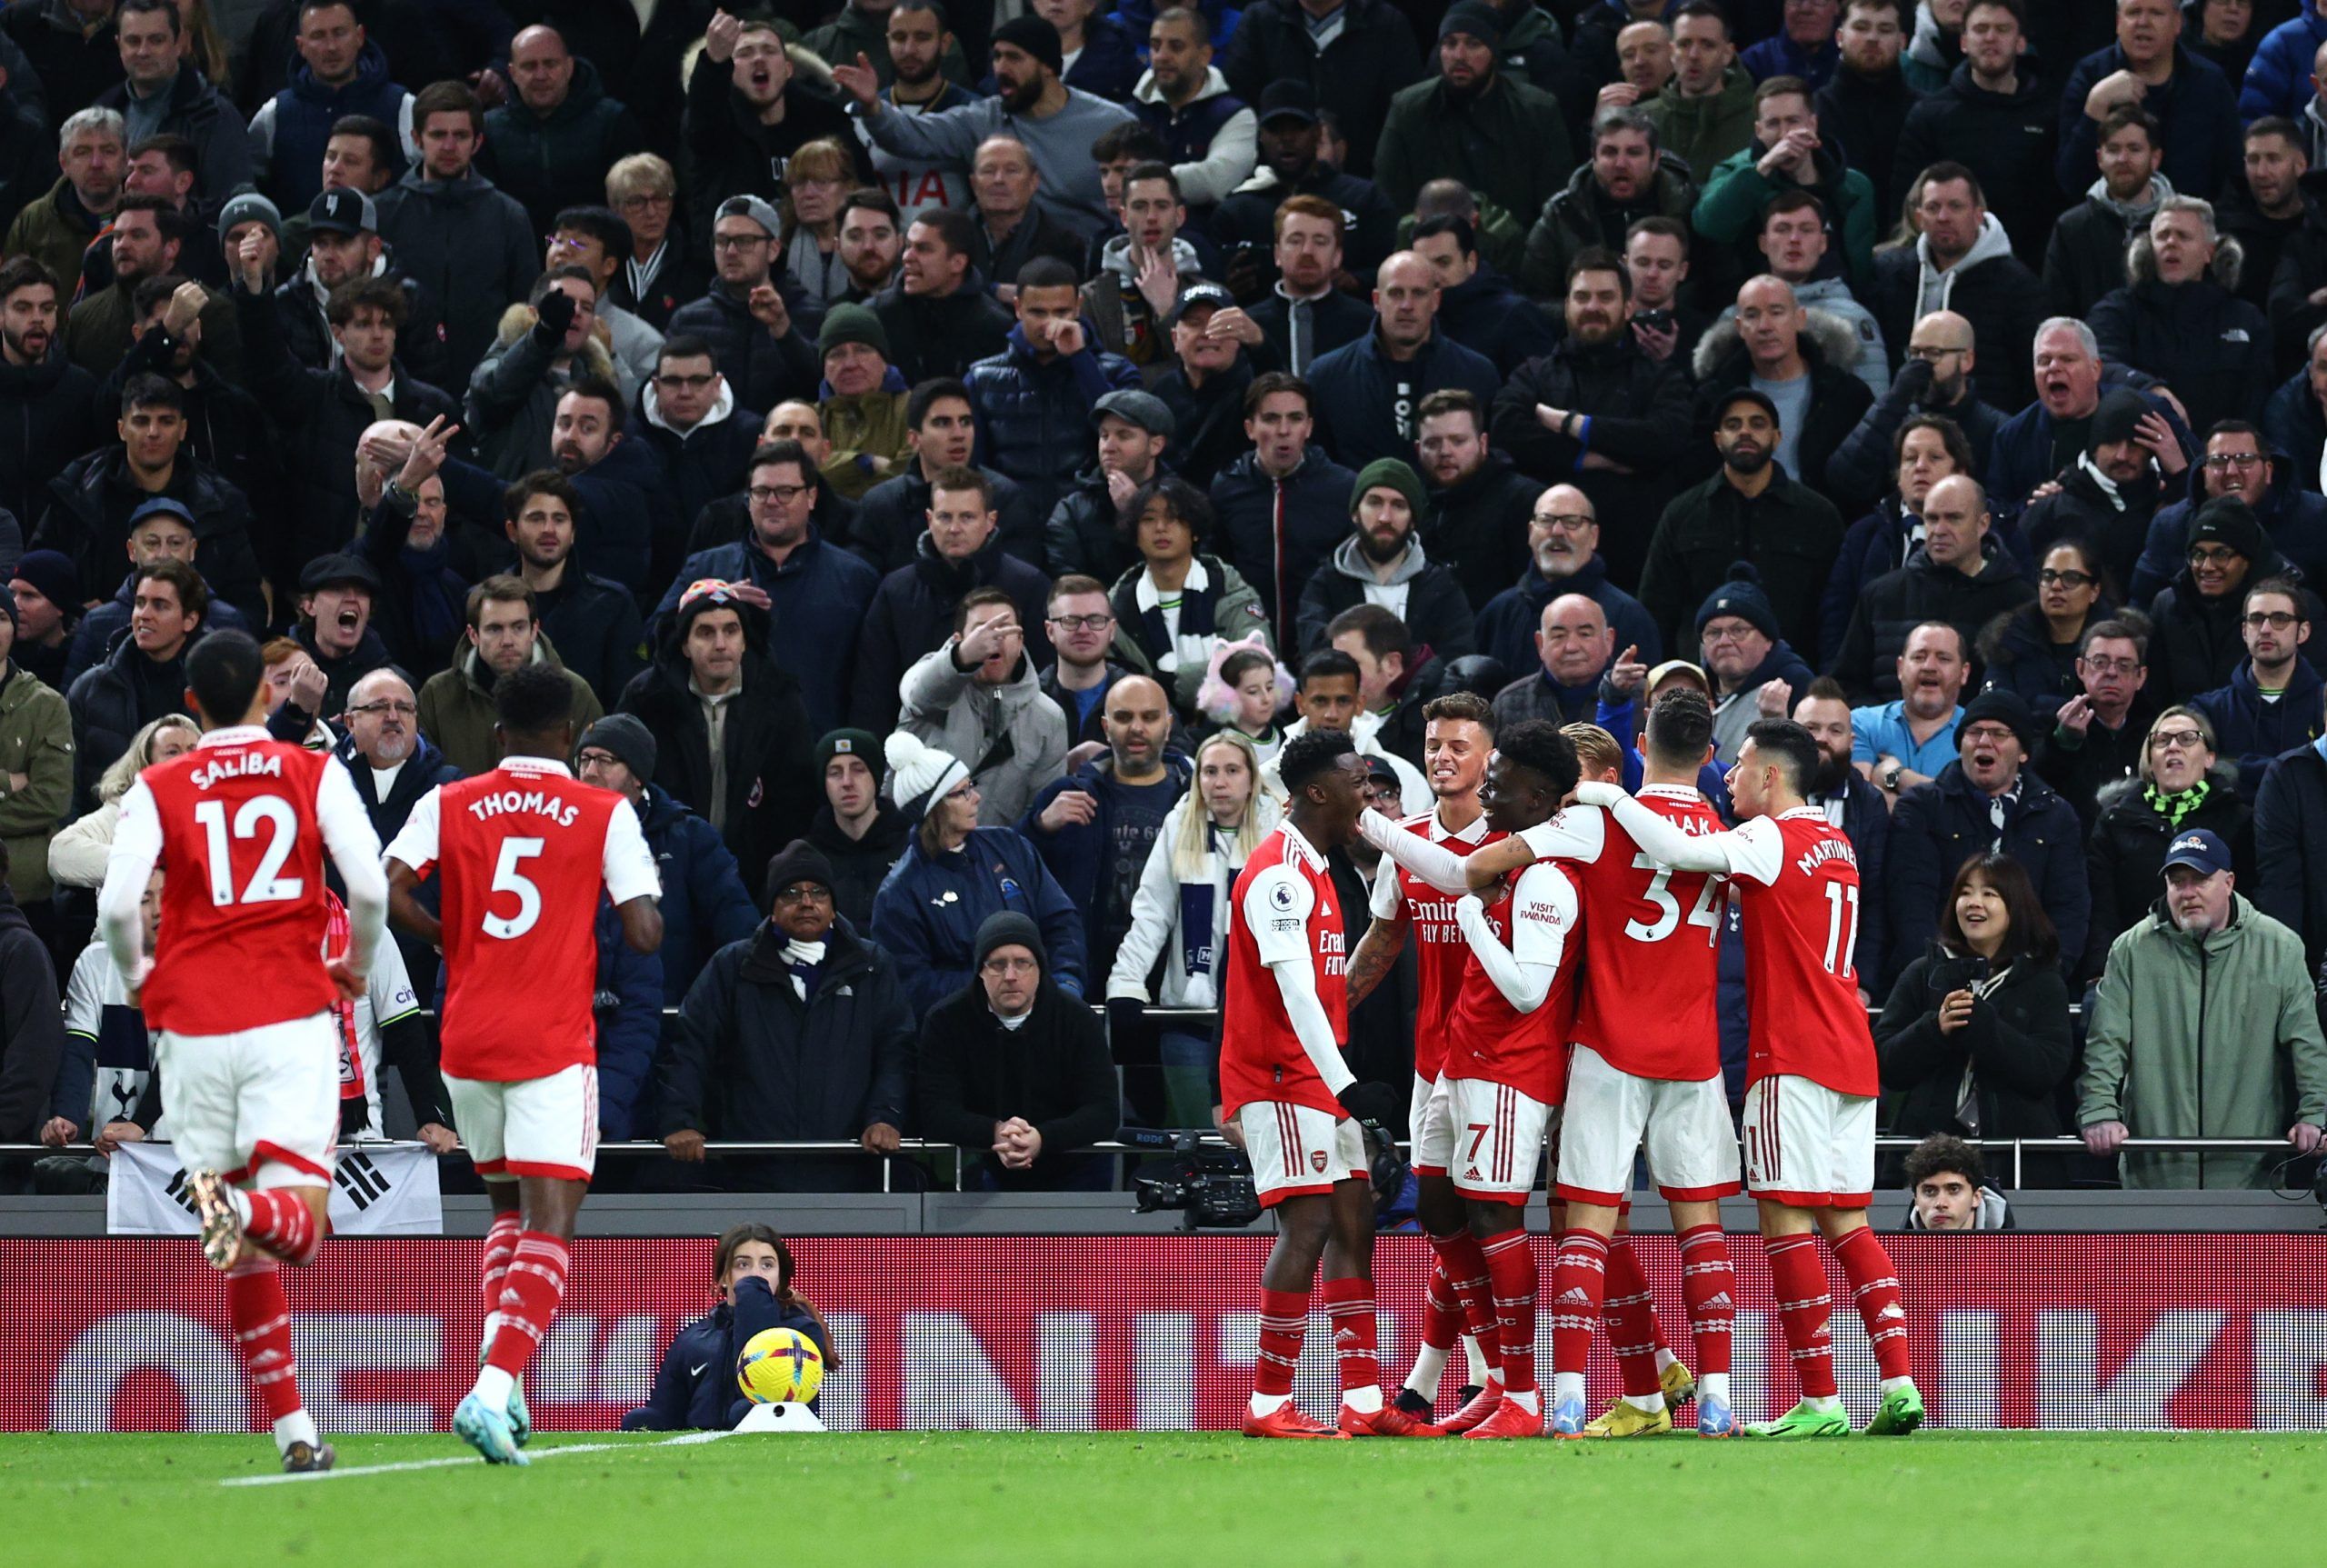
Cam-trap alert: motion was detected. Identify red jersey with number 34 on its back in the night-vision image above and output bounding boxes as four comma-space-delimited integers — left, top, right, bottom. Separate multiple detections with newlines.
1562, 784, 1724, 1082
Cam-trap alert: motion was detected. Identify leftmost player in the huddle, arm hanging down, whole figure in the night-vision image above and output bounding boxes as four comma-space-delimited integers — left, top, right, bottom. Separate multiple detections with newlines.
1219, 731, 1441, 1438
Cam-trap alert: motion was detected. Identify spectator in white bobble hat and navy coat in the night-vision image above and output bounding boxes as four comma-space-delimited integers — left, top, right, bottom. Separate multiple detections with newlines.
873, 731, 1084, 1016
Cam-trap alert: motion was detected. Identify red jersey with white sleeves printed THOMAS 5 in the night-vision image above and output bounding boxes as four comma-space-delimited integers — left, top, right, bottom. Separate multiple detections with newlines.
389, 756, 661, 1084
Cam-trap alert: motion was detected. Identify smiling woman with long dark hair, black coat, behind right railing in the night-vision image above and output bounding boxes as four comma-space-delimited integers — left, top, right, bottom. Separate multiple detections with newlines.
1875, 854, 2073, 1180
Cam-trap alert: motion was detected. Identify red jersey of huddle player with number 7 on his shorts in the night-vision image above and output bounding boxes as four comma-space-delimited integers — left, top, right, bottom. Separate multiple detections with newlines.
1441, 861, 1583, 1105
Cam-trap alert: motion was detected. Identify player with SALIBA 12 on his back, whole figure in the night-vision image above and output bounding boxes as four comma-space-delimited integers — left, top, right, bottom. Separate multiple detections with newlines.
98, 631, 386, 1473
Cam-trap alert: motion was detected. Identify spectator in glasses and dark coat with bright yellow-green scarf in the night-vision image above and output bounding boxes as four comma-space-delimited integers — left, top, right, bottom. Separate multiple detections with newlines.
2078, 686, 2252, 979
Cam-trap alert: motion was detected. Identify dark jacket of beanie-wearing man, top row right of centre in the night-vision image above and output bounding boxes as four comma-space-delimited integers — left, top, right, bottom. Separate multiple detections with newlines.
1373, 75, 1575, 232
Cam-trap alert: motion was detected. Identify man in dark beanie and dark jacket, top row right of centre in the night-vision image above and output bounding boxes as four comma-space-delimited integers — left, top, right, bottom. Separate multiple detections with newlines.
1373, 0, 1575, 214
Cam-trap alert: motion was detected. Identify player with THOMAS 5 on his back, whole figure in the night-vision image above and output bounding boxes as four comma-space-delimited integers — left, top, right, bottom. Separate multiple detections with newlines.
389, 663, 664, 1465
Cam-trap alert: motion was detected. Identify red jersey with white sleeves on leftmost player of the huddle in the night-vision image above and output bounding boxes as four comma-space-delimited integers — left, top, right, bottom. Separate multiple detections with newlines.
1219, 821, 1350, 1116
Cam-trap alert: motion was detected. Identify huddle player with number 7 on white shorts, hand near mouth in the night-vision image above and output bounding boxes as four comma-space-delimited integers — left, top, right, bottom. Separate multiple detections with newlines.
1443, 719, 1583, 1438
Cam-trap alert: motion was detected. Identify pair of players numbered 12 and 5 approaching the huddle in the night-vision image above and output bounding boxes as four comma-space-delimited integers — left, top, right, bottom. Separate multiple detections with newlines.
98, 631, 664, 1473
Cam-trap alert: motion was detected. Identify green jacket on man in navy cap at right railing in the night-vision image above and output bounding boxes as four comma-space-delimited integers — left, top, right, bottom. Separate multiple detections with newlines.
2076, 894, 2327, 1186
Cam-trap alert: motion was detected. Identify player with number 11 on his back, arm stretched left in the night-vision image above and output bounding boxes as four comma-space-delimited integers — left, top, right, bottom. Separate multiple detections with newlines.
1580, 719, 1923, 1438
